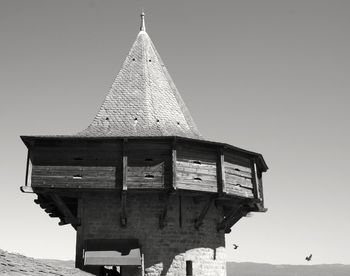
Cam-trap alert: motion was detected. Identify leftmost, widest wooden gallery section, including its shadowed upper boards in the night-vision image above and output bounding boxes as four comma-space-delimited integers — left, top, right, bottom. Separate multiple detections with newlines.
31, 142, 122, 188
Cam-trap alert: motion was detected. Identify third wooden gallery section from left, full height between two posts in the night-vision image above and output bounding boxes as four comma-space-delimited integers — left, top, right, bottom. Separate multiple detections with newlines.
176, 145, 218, 192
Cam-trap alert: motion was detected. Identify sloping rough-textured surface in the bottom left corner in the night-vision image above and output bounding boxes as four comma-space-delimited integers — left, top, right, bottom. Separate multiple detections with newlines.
0, 249, 92, 276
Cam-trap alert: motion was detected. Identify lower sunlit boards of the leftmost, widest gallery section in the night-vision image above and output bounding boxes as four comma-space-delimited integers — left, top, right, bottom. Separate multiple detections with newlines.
32, 165, 116, 188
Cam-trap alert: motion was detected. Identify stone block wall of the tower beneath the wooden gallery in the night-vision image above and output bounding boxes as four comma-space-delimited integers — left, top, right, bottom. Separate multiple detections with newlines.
81, 193, 226, 276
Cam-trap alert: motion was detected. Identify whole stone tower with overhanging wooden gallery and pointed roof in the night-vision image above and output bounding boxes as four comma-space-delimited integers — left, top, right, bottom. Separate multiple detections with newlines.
21, 13, 267, 276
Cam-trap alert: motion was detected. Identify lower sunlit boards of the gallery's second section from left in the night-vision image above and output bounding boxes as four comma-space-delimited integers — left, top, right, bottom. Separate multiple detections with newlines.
127, 162, 164, 189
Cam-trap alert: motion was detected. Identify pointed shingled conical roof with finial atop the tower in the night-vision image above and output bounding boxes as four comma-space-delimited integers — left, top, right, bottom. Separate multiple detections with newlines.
78, 14, 201, 139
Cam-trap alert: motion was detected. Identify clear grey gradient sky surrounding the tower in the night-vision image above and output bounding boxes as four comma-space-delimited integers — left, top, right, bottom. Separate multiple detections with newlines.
0, 0, 350, 264
